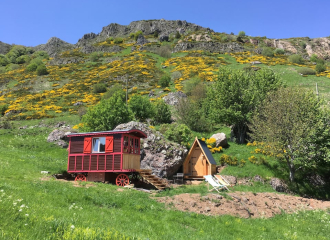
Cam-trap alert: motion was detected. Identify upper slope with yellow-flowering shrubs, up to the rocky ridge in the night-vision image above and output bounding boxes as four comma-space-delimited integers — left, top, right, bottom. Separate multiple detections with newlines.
0, 20, 330, 119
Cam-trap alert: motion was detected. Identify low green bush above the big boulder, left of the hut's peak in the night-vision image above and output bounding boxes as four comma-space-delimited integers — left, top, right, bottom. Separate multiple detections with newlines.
160, 123, 192, 145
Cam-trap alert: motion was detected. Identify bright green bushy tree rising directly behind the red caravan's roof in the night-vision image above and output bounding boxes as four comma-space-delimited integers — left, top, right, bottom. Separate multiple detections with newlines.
82, 92, 133, 132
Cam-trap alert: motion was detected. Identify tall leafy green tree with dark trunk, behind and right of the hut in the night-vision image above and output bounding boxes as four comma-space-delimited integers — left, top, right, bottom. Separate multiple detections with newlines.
204, 68, 282, 143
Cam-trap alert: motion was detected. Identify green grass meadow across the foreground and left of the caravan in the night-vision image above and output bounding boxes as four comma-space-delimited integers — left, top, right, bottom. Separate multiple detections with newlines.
0, 121, 330, 239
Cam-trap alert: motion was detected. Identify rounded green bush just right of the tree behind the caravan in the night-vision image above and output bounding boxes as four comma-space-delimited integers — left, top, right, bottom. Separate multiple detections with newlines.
128, 95, 155, 122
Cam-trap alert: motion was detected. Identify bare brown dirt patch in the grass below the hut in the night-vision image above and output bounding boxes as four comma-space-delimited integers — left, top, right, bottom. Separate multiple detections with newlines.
153, 192, 330, 218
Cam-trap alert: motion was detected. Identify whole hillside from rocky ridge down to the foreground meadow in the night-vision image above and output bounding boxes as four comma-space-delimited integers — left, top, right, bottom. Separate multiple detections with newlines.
0, 19, 330, 239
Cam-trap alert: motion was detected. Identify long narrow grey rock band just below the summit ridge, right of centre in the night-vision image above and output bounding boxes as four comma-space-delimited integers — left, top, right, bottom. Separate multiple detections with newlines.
173, 42, 245, 53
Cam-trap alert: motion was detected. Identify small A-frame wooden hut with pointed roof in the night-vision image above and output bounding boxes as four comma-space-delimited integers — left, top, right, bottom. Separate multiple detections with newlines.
183, 137, 216, 179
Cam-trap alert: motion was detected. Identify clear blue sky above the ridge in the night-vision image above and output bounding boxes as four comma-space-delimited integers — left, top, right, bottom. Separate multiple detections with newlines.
0, 0, 330, 46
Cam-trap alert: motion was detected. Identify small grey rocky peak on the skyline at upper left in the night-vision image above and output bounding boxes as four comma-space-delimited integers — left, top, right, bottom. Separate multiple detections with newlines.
34, 37, 74, 57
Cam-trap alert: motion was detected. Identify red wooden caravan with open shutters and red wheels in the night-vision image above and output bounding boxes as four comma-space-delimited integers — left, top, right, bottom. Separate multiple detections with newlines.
68, 129, 147, 186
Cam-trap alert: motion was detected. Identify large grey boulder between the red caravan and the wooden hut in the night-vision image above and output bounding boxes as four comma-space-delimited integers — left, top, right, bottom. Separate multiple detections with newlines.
115, 121, 188, 177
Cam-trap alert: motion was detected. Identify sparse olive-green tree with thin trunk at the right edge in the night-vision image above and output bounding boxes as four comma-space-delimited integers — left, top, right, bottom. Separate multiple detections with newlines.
250, 88, 330, 182
